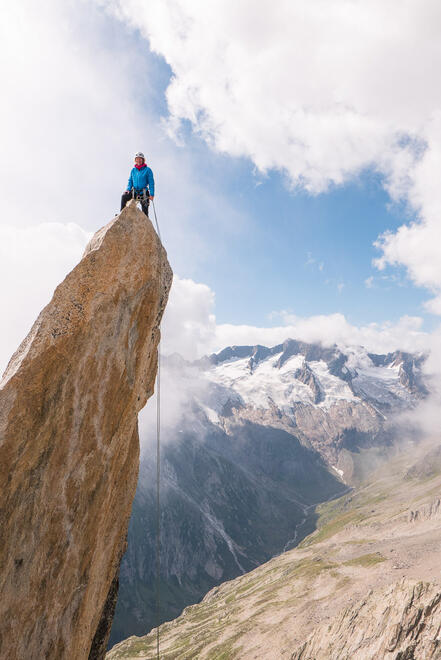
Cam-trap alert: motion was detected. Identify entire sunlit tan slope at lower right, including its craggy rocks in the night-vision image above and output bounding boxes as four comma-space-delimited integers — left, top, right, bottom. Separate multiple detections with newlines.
107, 438, 441, 660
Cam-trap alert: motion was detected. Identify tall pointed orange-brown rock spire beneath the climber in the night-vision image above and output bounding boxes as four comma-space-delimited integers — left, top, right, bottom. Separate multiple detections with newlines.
0, 203, 172, 660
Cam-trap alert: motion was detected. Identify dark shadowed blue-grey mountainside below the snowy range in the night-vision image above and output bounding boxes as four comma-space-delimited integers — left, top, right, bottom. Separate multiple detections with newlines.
111, 424, 346, 641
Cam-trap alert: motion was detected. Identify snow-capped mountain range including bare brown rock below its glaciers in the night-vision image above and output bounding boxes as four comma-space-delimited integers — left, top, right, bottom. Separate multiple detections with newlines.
191, 339, 426, 470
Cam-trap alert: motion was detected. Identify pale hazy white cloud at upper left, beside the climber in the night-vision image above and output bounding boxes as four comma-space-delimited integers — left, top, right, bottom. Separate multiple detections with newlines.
0, 0, 140, 227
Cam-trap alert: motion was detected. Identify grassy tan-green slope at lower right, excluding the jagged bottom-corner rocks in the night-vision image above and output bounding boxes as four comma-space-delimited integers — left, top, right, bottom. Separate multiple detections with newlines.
108, 438, 441, 660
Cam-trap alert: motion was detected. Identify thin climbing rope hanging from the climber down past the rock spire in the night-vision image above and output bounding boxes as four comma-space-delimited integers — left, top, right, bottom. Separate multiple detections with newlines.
152, 199, 162, 660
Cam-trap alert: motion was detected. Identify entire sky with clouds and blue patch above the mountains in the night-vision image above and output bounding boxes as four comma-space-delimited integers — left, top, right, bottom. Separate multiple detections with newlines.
0, 0, 441, 370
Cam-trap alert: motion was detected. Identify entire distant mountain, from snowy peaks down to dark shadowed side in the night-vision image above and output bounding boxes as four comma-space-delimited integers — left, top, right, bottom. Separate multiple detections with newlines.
111, 340, 425, 643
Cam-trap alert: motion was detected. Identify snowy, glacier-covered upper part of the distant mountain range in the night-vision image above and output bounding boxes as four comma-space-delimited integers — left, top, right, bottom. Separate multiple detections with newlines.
202, 339, 423, 414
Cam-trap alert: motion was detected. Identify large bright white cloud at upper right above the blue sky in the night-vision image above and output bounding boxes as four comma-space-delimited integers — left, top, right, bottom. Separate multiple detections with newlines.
100, 0, 441, 313
